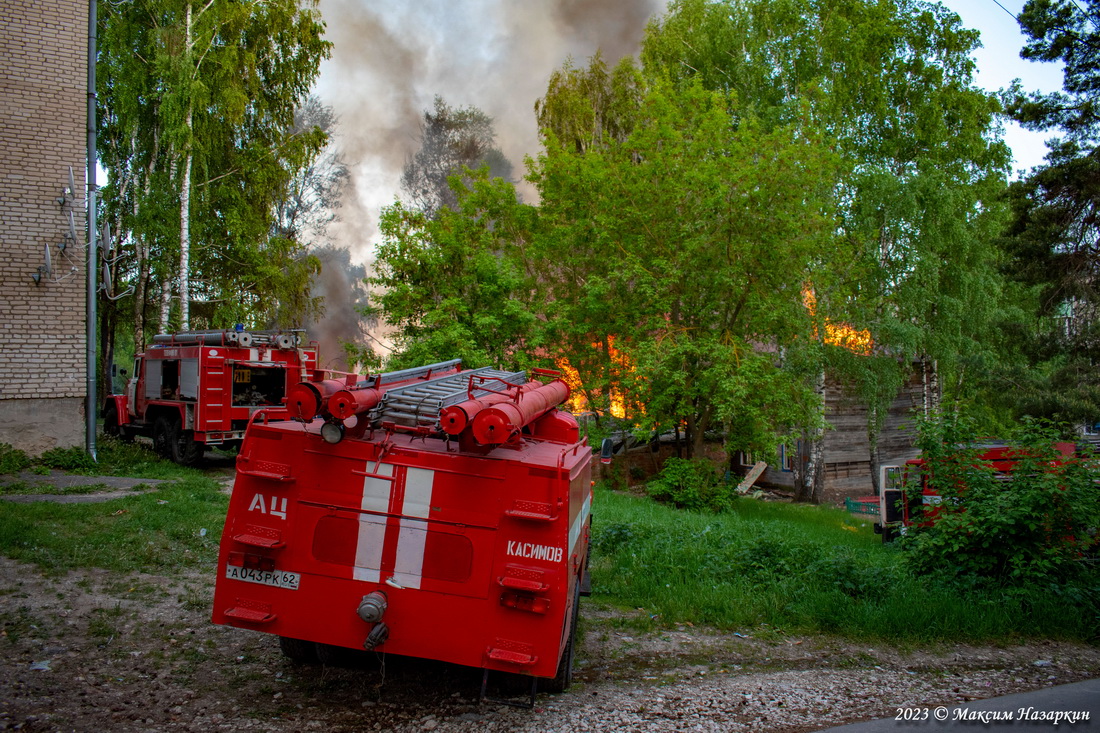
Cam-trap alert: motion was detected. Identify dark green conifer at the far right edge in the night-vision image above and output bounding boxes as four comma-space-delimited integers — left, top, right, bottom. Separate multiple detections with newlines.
992, 0, 1100, 424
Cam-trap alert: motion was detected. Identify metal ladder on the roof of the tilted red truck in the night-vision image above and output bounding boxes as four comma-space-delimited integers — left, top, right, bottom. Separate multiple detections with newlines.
371, 367, 527, 427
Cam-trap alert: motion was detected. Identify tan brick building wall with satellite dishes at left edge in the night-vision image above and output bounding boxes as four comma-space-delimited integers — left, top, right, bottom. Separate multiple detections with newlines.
0, 0, 88, 453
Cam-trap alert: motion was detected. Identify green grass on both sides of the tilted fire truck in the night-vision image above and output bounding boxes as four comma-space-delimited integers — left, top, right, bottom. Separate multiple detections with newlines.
0, 431, 1098, 644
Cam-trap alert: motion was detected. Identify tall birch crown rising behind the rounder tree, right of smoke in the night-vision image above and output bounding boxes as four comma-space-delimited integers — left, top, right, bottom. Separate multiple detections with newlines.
642, 0, 1008, 391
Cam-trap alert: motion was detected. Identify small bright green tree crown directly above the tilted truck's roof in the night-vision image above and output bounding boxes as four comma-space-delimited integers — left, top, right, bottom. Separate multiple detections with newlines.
370, 167, 538, 369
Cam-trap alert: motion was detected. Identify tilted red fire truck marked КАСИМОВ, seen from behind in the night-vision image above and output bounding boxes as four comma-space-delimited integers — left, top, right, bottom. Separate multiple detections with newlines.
213, 361, 592, 697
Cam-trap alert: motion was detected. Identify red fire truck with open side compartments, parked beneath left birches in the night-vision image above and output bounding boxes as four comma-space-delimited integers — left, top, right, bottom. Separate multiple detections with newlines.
102, 330, 317, 466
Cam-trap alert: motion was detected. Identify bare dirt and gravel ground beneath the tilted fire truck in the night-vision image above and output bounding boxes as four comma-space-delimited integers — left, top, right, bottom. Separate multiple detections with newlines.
0, 558, 1100, 732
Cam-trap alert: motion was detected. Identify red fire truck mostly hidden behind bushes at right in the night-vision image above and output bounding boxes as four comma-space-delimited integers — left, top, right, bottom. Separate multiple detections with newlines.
875, 435, 1076, 543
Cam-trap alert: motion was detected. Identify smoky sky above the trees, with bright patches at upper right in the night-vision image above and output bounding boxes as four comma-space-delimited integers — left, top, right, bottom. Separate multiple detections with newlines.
317, 0, 1062, 262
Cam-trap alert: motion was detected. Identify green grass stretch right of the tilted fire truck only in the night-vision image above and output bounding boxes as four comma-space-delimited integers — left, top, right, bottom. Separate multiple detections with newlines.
591, 486, 1096, 643
